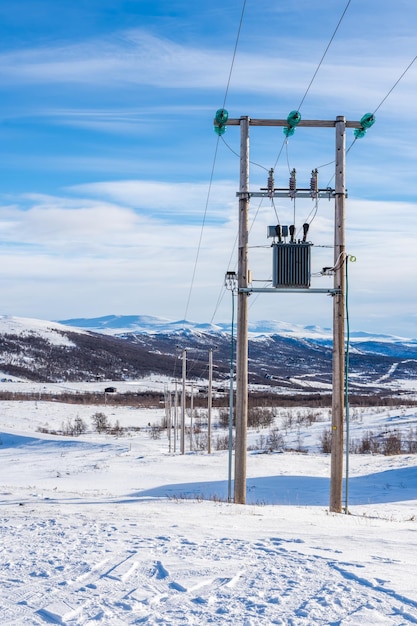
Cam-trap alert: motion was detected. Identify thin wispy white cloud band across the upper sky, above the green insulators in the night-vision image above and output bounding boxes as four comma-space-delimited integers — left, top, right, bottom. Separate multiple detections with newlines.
0, 30, 417, 113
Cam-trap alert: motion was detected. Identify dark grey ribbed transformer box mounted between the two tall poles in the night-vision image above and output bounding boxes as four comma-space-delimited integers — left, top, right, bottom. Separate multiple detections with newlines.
272, 241, 312, 288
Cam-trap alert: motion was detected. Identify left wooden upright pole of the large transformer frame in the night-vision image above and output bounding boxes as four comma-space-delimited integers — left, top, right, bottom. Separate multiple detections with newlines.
234, 117, 249, 504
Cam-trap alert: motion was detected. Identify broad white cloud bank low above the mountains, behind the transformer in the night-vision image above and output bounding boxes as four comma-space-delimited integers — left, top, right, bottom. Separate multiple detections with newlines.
0, 181, 417, 334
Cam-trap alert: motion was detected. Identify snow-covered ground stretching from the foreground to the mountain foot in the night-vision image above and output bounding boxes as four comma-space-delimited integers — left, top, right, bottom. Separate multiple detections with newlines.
0, 394, 417, 626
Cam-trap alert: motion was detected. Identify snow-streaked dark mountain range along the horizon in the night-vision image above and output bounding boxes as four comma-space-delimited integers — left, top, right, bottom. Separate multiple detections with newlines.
0, 315, 417, 394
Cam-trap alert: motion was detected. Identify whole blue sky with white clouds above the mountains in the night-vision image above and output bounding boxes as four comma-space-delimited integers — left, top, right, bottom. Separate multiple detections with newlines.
0, 0, 417, 337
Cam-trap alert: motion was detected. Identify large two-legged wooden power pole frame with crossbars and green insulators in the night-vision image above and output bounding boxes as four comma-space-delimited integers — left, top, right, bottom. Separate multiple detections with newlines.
214, 110, 362, 513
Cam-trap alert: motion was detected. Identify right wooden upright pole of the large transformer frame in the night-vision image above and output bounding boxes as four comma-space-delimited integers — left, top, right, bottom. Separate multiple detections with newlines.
329, 116, 346, 513
